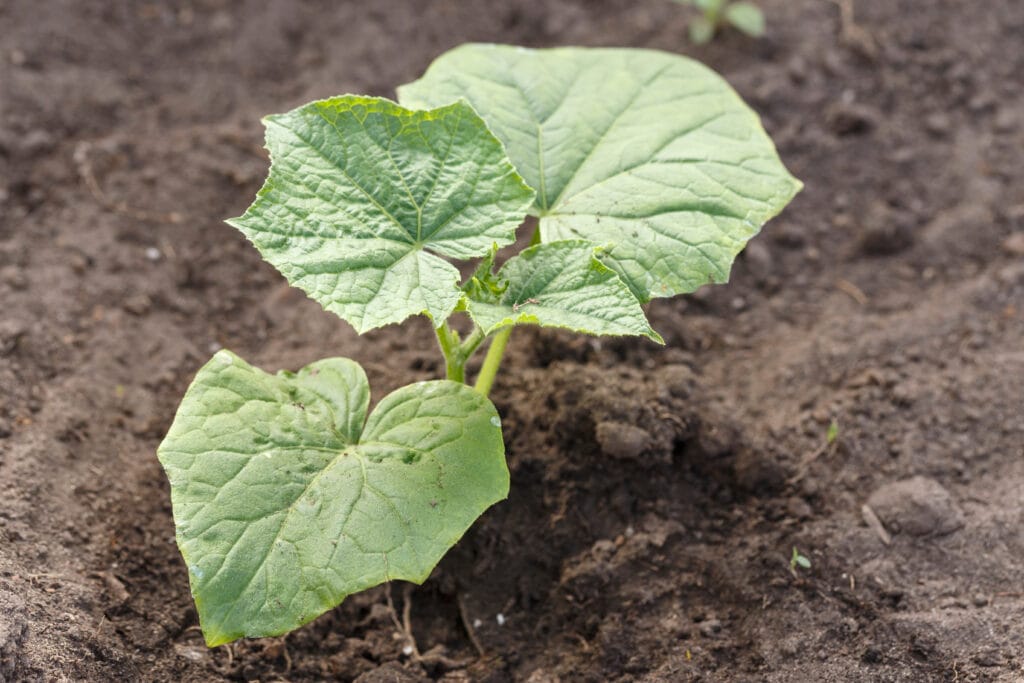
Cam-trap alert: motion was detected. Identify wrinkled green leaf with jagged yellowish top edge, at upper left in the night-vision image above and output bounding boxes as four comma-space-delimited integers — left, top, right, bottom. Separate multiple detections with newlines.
227, 95, 534, 333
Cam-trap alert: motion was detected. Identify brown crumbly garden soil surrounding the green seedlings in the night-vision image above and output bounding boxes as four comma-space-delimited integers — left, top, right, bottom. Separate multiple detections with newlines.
0, 0, 1024, 683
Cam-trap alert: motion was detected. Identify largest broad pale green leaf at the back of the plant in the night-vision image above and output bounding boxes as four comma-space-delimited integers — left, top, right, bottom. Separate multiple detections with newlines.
398, 44, 801, 301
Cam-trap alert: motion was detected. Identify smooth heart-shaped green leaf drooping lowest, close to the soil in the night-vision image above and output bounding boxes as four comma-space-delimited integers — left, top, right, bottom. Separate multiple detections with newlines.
159, 350, 509, 647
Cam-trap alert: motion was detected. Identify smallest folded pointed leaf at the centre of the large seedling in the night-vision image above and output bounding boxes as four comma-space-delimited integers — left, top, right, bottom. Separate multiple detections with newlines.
467, 240, 664, 344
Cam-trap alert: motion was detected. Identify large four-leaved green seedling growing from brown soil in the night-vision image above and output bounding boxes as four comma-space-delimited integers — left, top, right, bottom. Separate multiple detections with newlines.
159, 45, 801, 646
